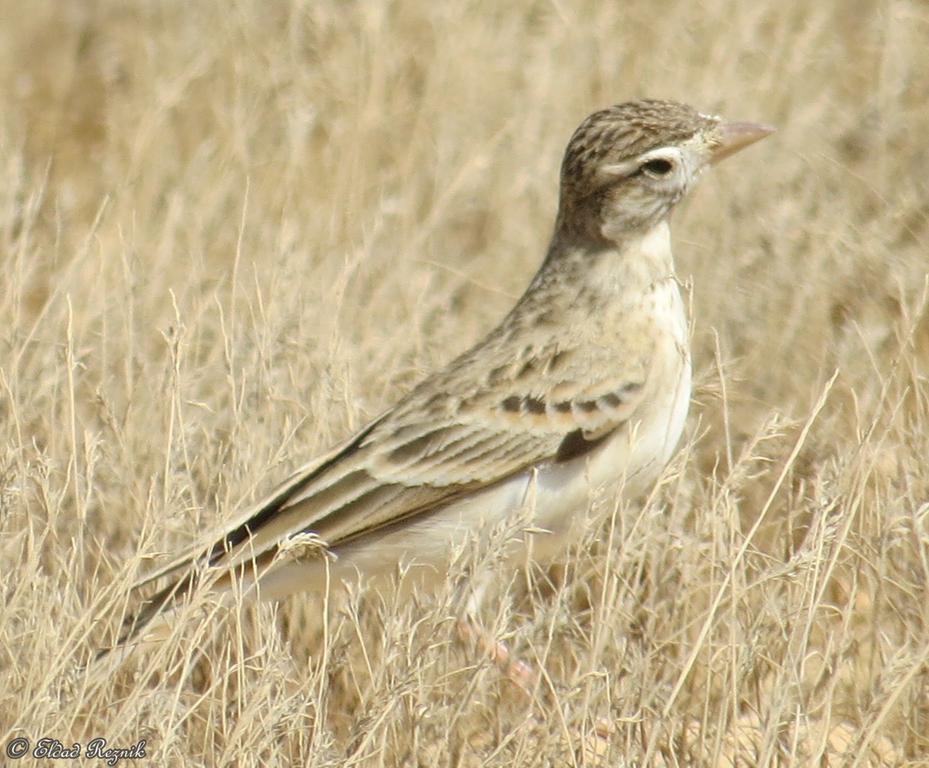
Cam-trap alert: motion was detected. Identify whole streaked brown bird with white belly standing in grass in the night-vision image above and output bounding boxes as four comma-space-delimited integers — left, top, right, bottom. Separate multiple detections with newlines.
114, 99, 774, 672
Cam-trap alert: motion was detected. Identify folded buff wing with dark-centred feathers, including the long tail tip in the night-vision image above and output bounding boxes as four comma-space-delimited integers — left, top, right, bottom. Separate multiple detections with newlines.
124, 330, 652, 639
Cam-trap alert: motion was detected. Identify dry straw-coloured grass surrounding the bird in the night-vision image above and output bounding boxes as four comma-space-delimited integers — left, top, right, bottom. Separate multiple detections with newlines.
0, 0, 929, 767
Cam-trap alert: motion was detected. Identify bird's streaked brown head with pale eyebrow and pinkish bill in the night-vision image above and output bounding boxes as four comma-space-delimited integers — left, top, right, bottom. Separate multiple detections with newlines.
558, 100, 774, 243
